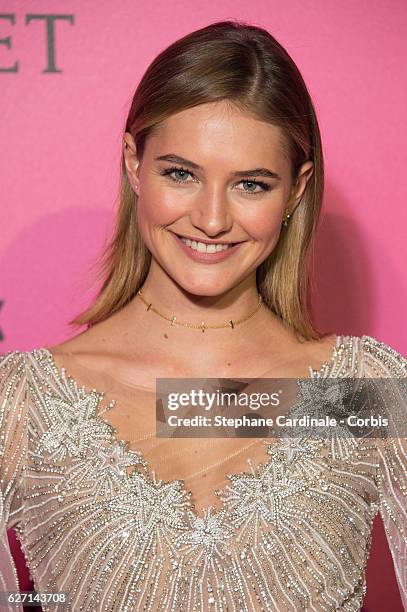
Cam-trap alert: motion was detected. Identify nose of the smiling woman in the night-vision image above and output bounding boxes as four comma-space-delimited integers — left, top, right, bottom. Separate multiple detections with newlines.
190, 186, 233, 237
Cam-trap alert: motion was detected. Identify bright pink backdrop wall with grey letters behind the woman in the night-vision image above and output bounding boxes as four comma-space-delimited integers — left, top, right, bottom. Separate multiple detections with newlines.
0, 0, 407, 611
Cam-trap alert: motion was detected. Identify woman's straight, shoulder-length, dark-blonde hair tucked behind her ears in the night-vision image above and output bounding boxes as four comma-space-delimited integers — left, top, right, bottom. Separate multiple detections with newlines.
69, 21, 332, 340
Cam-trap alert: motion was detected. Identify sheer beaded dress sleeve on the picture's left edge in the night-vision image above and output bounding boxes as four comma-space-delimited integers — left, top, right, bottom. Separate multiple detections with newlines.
0, 351, 27, 611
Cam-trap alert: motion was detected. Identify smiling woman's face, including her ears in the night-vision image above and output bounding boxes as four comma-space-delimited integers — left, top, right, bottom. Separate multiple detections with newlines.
124, 102, 312, 296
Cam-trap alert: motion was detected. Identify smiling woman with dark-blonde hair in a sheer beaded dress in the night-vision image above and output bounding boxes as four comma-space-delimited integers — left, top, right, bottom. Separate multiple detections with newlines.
0, 22, 407, 611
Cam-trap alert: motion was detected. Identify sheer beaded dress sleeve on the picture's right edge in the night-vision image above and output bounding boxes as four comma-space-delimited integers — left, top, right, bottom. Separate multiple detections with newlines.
363, 336, 407, 611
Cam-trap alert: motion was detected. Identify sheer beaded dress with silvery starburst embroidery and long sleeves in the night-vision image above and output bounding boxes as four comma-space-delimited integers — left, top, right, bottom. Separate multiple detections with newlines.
0, 336, 407, 612
